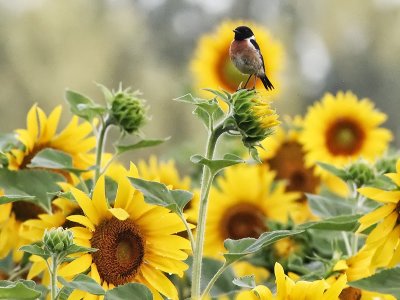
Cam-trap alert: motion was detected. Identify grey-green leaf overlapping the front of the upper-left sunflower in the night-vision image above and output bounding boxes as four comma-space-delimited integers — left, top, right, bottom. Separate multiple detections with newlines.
28, 148, 85, 173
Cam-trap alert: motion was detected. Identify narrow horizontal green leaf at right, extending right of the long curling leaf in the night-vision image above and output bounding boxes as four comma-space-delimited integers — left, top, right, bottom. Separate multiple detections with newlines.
296, 214, 362, 231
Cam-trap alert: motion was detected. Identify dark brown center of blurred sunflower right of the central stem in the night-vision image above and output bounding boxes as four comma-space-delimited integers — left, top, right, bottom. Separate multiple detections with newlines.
222, 203, 268, 240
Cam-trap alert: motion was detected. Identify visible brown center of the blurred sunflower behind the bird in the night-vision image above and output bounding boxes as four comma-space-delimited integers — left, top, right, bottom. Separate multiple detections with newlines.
216, 52, 247, 91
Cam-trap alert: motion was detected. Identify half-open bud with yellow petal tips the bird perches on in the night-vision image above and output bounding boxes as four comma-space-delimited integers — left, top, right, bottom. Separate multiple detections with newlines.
232, 90, 280, 148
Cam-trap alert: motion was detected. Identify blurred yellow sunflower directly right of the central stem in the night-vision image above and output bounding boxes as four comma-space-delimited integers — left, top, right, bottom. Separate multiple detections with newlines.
204, 165, 299, 257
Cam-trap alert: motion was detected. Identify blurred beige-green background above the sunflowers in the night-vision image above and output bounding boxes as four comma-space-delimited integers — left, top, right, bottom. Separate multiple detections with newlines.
0, 0, 400, 168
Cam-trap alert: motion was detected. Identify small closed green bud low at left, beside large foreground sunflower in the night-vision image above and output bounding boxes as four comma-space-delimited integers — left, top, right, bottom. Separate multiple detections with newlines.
43, 227, 74, 253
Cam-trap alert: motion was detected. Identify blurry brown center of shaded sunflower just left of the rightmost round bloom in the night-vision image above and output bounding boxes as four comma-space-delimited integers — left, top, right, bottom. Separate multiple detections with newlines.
266, 141, 320, 198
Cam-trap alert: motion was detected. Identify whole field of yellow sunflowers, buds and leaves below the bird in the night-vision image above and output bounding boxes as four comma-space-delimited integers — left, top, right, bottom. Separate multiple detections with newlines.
0, 15, 400, 300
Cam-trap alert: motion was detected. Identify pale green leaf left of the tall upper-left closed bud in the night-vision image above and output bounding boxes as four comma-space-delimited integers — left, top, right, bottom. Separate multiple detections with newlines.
65, 90, 106, 121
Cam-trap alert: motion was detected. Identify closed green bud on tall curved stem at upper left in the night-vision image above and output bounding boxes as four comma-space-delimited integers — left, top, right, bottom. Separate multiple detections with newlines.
111, 89, 146, 133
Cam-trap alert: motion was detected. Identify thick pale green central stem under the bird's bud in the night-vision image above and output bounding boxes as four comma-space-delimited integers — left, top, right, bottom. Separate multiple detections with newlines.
191, 123, 223, 300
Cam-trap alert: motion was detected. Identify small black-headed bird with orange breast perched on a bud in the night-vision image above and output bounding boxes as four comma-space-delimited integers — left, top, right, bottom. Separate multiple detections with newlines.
229, 26, 274, 91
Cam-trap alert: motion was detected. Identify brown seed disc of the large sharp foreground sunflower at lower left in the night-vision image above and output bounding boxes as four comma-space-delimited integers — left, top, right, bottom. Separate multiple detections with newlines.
90, 217, 145, 285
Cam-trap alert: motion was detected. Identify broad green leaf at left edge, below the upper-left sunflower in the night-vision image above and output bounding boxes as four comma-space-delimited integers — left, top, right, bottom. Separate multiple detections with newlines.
0, 169, 65, 211
